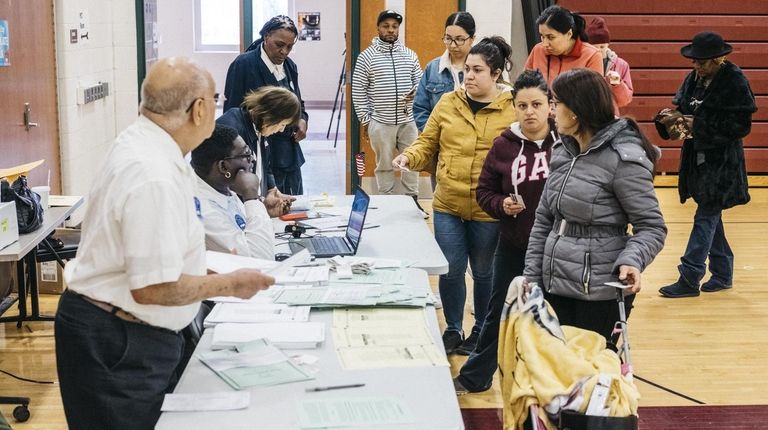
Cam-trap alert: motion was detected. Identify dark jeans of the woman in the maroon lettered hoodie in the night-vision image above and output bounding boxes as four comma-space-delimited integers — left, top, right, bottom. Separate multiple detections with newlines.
458, 242, 525, 391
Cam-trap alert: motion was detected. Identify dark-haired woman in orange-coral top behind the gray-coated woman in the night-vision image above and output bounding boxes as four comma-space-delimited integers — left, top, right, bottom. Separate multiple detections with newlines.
525, 5, 603, 85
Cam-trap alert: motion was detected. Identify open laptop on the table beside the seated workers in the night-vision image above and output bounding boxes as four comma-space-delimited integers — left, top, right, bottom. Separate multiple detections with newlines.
288, 187, 371, 258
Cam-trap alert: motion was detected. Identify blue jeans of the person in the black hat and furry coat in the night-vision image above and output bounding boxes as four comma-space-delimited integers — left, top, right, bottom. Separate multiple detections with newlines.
677, 206, 733, 288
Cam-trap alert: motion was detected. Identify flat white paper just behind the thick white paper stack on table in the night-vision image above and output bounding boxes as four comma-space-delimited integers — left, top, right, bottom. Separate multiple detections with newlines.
205, 303, 310, 327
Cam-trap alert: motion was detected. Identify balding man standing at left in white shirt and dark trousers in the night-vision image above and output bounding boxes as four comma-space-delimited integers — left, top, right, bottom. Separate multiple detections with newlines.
55, 58, 274, 429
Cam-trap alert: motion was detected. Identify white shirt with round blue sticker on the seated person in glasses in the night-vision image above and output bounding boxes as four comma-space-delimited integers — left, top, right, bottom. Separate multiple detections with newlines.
197, 177, 275, 260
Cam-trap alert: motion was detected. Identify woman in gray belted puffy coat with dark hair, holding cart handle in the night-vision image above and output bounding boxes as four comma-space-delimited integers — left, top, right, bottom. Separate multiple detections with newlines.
524, 69, 667, 339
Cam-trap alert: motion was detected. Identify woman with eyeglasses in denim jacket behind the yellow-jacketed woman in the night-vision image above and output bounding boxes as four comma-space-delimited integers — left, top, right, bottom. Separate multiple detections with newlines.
413, 12, 475, 192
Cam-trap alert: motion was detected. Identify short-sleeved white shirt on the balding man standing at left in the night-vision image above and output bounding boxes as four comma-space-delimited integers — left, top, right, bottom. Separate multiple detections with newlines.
64, 116, 206, 330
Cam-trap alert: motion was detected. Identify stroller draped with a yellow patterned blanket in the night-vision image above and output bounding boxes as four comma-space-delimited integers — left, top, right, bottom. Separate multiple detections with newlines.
499, 278, 639, 430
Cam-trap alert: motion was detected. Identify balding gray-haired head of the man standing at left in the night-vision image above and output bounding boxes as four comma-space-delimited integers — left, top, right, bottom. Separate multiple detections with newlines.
140, 59, 209, 131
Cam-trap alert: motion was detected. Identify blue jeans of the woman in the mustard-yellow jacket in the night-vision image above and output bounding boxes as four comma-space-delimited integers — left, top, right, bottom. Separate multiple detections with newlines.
434, 211, 499, 332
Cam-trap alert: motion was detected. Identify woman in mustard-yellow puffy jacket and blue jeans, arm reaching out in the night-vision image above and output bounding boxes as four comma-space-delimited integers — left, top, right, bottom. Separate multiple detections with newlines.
392, 36, 516, 355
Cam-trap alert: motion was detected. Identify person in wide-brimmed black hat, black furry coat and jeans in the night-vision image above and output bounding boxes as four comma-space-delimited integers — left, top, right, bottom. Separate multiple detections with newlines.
656, 32, 757, 298
